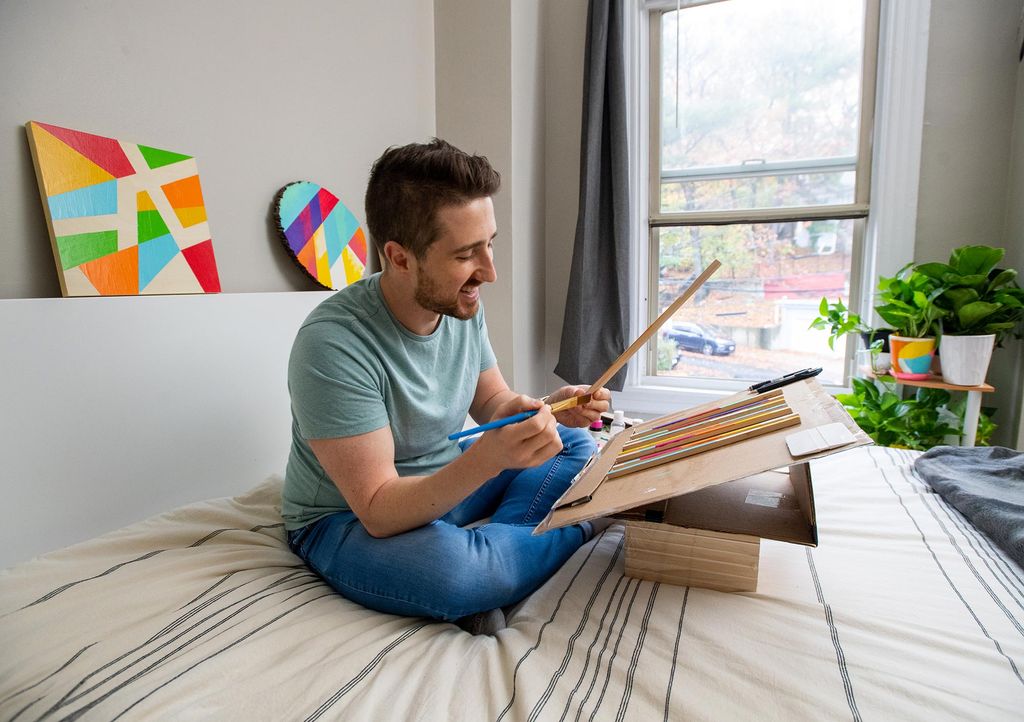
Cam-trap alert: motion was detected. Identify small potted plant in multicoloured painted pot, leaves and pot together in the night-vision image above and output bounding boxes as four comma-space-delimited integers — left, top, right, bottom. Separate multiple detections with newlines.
874, 263, 945, 379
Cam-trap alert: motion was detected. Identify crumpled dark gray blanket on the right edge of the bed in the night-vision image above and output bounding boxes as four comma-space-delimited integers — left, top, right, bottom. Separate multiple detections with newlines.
913, 447, 1024, 566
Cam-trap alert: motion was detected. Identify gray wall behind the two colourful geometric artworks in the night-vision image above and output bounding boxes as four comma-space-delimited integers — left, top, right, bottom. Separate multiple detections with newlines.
0, 0, 434, 298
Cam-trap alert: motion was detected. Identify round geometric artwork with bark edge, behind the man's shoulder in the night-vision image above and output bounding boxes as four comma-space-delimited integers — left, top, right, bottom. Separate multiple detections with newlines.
273, 180, 367, 291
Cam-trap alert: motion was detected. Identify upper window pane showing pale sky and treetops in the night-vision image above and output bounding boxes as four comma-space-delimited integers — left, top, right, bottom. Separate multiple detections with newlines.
659, 0, 863, 211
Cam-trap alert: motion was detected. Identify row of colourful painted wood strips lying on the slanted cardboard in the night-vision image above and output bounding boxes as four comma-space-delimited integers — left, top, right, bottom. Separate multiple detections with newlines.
607, 390, 800, 479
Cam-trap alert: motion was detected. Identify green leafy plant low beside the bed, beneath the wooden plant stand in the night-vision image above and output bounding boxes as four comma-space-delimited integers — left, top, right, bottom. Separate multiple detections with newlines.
836, 379, 995, 451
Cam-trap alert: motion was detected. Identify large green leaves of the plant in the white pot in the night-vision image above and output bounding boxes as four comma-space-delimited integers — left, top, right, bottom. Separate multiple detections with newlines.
914, 246, 1024, 346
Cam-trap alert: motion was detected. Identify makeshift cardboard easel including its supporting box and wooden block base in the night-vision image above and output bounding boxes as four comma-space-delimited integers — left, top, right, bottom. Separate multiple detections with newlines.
535, 379, 870, 591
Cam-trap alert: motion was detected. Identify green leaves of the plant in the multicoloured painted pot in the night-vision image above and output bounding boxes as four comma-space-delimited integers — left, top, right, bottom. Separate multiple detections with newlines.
874, 263, 945, 338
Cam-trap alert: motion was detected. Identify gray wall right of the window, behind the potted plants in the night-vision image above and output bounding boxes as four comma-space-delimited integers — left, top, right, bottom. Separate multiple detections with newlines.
908, 0, 1024, 445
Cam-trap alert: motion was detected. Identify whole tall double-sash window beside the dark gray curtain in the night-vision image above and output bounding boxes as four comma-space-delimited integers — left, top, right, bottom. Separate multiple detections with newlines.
641, 0, 879, 387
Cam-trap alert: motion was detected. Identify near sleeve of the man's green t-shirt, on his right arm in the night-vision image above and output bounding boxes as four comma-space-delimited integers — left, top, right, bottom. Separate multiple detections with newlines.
288, 322, 388, 439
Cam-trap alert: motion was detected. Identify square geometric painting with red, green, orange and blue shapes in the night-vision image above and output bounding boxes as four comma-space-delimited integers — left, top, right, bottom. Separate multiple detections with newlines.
26, 121, 220, 296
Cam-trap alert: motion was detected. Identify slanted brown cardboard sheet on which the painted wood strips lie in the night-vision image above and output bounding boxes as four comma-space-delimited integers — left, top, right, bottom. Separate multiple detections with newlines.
535, 379, 870, 532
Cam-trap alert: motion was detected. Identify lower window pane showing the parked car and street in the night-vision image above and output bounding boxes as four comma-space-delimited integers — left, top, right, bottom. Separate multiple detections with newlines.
652, 220, 854, 384
